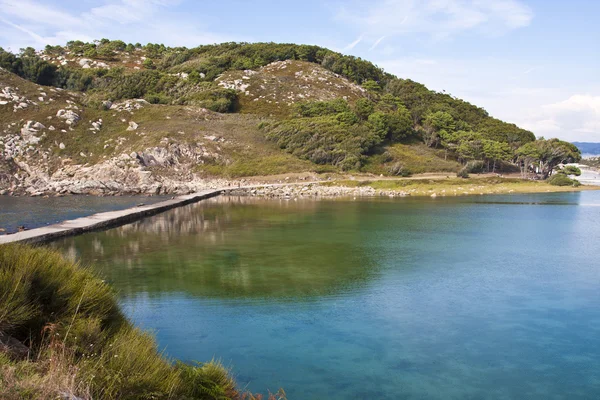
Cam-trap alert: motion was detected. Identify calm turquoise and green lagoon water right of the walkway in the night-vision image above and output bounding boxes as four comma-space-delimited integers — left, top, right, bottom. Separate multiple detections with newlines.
56, 192, 600, 399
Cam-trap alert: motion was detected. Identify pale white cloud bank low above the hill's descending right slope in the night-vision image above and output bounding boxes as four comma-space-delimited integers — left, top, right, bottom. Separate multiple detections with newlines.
377, 57, 600, 142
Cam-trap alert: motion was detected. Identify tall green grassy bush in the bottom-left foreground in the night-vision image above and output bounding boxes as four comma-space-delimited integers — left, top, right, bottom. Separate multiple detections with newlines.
0, 245, 284, 400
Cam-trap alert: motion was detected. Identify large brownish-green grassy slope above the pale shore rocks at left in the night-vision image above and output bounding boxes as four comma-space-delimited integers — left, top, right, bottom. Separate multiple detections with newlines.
0, 71, 320, 177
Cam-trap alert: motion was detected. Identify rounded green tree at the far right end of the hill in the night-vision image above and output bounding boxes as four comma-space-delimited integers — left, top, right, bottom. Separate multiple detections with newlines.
516, 139, 581, 179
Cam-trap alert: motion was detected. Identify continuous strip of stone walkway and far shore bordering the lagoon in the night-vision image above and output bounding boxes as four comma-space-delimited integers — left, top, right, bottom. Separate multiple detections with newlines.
0, 178, 600, 245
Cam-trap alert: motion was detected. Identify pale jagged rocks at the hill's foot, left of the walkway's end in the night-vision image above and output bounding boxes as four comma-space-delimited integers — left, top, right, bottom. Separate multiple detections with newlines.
0, 141, 227, 196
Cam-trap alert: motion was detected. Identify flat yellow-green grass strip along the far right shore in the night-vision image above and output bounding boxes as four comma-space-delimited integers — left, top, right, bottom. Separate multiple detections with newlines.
326, 178, 600, 196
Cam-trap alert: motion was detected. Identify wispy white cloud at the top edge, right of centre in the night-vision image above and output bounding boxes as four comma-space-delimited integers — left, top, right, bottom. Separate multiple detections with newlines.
336, 0, 533, 39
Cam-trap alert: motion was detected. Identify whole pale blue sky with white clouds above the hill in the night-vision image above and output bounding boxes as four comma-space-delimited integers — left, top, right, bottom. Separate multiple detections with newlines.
0, 0, 600, 142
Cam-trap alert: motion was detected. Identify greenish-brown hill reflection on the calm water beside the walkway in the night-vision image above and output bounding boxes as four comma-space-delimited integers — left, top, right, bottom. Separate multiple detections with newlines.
58, 197, 376, 298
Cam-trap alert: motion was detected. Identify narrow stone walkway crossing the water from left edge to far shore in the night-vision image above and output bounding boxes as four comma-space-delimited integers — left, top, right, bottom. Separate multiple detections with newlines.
0, 182, 322, 245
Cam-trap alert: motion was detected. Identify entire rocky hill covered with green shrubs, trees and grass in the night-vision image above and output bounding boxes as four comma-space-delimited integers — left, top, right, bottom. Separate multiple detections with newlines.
0, 39, 579, 195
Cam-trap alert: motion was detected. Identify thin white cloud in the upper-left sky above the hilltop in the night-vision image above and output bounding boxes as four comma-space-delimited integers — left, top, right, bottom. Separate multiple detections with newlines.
0, 0, 234, 51
